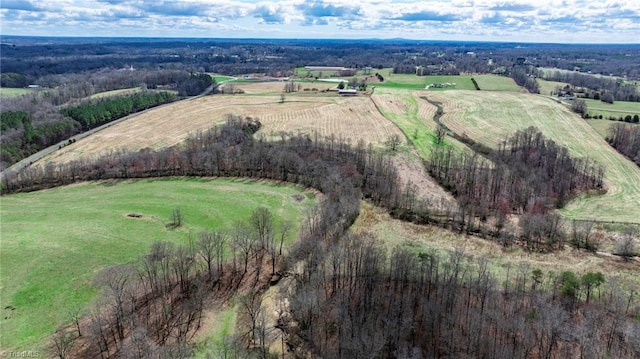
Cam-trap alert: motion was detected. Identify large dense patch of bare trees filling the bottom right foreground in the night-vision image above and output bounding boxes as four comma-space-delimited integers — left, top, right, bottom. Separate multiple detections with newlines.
284, 235, 640, 358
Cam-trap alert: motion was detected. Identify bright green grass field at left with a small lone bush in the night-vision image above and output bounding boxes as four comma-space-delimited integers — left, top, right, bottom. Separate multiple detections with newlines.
0, 179, 315, 351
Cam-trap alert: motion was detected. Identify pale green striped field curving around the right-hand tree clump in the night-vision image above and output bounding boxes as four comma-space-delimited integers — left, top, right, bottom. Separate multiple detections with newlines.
424, 91, 640, 223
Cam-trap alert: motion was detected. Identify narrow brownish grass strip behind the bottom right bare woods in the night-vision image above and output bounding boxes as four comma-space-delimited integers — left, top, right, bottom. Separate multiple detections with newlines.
352, 203, 640, 289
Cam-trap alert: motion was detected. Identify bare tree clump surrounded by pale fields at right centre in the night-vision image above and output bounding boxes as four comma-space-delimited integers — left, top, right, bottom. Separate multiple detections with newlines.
428, 127, 604, 248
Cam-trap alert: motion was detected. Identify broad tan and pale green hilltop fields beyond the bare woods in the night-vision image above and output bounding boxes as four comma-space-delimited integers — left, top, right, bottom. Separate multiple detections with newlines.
31, 83, 640, 223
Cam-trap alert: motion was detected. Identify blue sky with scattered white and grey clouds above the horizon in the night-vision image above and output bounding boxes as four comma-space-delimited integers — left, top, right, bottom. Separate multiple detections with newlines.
0, 0, 640, 43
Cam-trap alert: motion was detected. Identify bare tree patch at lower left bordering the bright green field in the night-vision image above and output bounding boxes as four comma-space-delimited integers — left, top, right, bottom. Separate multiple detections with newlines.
69, 207, 290, 358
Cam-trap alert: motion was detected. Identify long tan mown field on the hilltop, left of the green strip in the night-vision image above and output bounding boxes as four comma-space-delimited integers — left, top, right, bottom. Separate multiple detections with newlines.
37, 91, 402, 164
